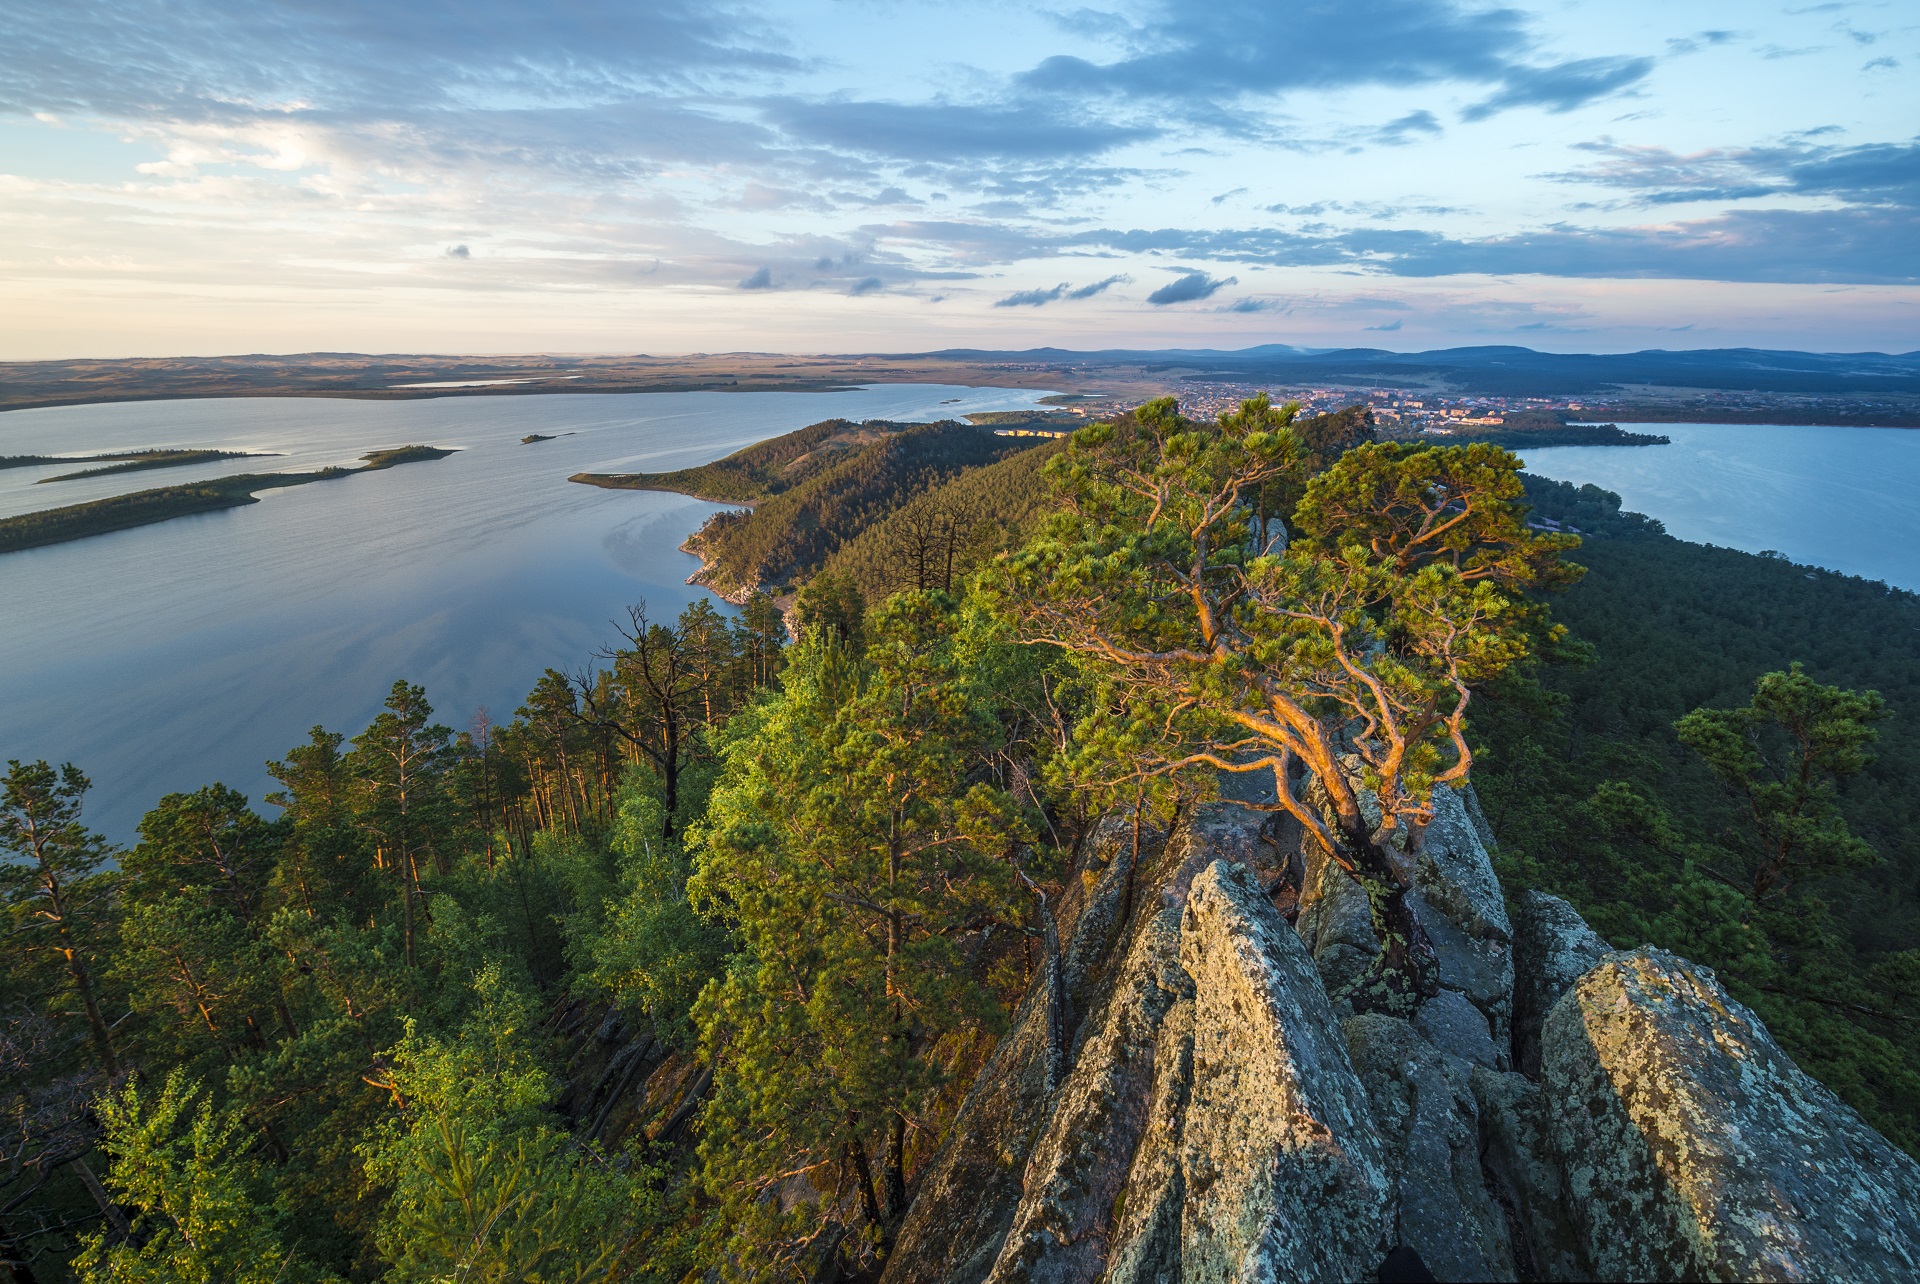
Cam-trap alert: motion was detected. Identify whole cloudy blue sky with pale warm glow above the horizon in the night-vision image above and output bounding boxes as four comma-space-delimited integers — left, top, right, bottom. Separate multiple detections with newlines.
0, 0, 1920, 359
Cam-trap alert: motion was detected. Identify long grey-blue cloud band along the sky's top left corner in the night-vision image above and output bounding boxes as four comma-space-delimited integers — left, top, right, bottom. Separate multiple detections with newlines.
0, 0, 799, 119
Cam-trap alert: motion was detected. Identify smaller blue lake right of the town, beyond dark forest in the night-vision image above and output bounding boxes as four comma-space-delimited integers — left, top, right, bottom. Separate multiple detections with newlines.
1526, 424, 1920, 589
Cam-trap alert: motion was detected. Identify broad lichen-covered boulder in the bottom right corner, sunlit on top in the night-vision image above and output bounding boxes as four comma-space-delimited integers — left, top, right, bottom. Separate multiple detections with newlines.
1540, 946, 1920, 1280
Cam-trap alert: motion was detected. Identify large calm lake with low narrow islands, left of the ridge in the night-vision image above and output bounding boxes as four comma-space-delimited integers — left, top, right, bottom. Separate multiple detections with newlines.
0, 384, 1043, 841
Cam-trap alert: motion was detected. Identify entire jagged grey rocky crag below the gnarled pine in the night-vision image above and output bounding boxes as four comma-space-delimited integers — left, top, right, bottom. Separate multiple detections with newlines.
885, 791, 1920, 1284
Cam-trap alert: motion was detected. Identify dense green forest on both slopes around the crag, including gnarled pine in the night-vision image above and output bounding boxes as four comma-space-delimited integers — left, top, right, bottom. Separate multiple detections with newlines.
0, 399, 1920, 1284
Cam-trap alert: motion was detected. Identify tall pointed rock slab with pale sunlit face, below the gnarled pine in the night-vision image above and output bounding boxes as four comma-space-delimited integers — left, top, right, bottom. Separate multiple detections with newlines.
1179, 862, 1390, 1282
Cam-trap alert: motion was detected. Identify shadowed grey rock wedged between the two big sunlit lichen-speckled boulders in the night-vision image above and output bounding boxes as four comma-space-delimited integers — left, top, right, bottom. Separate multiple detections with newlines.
1346, 998, 1517, 1280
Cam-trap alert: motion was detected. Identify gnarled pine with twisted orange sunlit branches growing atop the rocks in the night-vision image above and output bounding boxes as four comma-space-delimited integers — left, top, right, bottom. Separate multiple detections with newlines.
996, 397, 1578, 1008
